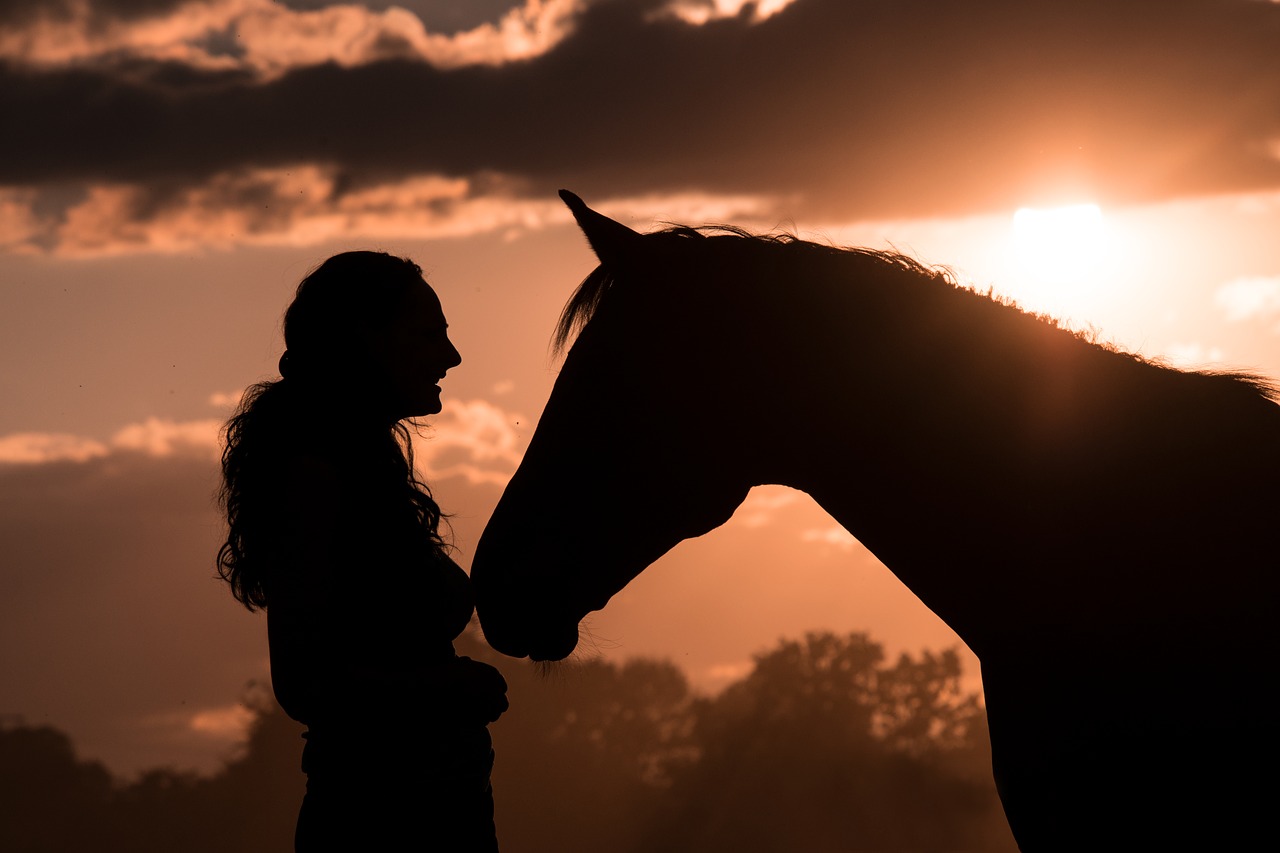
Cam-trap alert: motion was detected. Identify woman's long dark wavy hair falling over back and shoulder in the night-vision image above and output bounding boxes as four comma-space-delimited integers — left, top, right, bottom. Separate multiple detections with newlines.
218, 251, 448, 611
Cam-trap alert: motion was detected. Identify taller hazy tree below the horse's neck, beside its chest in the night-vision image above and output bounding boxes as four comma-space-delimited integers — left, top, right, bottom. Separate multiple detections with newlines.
649, 633, 1014, 852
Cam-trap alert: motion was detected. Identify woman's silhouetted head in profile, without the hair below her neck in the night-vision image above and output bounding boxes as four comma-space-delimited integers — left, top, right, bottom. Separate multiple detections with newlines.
280, 251, 462, 421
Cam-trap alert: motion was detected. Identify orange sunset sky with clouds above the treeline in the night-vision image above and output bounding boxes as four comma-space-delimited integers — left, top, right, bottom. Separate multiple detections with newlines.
0, 0, 1280, 772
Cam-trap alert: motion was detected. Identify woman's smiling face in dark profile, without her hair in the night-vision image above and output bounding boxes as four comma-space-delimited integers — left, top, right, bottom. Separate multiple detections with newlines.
372, 282, 462, 420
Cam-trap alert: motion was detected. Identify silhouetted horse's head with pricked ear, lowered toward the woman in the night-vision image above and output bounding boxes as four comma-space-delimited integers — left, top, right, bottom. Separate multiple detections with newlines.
471, 192, 759, 660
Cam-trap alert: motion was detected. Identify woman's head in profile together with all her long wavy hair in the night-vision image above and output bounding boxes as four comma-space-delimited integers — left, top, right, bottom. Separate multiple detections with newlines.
218, 252, 462, 610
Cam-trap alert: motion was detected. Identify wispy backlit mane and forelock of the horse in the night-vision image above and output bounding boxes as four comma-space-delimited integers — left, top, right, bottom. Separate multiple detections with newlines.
552, 224, 1280, 403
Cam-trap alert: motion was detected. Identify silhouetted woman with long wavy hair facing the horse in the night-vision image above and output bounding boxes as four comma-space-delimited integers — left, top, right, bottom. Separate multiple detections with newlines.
218, 252, 507, 852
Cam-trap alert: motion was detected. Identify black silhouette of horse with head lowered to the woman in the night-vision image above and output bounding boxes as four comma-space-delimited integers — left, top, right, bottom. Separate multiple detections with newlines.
472, 193, 1280, 850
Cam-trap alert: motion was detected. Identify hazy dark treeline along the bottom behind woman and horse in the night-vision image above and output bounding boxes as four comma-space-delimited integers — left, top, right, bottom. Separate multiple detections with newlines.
0, 634, 1016, 853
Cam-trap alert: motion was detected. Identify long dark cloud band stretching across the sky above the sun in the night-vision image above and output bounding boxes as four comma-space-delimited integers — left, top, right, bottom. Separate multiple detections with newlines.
0, 0, 1280, 216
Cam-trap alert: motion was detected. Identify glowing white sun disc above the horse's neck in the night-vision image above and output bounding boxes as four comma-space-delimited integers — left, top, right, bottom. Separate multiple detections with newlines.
1012, 204, 1107, 286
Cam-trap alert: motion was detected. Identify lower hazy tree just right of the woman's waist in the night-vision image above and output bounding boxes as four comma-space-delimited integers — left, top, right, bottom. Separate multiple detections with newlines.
457, 625, 692, 853
